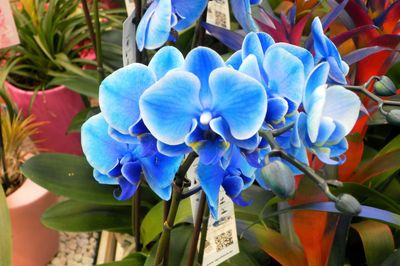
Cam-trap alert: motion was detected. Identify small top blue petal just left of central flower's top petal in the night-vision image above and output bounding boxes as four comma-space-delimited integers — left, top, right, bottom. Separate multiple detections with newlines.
149, 46, 185, 80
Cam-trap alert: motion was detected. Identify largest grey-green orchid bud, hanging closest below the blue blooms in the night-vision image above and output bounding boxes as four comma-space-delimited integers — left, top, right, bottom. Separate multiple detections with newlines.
261, 161, 296, 199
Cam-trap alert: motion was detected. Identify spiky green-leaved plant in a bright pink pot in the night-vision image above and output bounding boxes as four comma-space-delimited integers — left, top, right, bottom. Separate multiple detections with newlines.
2, 0, 122, 154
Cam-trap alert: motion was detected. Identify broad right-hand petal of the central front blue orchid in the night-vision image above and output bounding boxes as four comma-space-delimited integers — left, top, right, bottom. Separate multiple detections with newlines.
210, 68, 267, 140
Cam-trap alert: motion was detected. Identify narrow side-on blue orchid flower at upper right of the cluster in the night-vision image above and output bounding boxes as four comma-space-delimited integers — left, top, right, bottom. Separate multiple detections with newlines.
311, 17, 349, 84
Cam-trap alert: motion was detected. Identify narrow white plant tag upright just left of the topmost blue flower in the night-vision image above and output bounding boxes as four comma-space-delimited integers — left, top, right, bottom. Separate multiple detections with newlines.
122, 9, 136, 66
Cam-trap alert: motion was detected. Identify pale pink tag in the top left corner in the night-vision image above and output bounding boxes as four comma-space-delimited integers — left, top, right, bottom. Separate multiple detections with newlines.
0, 0, 20, 49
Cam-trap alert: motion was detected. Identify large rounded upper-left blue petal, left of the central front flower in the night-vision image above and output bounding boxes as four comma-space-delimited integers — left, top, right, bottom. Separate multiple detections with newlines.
99, 63, 156, 134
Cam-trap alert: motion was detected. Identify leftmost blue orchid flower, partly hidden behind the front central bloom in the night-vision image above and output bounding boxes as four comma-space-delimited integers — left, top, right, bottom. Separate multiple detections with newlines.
82, 47, 188, 199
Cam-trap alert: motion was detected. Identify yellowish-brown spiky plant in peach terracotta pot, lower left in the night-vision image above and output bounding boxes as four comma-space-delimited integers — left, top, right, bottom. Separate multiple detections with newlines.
0, 105, 59, 265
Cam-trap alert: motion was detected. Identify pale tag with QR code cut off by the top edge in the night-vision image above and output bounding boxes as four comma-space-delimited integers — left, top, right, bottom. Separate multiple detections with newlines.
207, 0, 231, 30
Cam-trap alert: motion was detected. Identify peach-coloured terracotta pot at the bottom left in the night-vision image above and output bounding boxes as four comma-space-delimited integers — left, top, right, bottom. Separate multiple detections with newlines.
7, 179, 59, 266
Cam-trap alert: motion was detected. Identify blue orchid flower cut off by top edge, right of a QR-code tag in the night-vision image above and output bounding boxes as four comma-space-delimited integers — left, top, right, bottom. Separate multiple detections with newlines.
231, 0, 262, 32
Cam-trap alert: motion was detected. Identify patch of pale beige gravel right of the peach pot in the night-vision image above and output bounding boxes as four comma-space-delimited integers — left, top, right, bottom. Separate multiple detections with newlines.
48, 232, 99, 266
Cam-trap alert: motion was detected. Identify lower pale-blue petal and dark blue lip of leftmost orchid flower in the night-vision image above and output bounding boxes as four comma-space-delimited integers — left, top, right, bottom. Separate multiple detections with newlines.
81, 113, 183, 200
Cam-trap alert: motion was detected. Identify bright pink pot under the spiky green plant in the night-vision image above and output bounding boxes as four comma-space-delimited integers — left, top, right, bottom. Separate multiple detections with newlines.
6, 83, 84, 155
